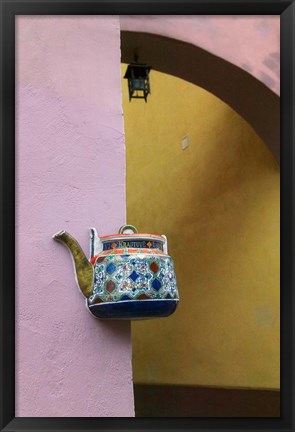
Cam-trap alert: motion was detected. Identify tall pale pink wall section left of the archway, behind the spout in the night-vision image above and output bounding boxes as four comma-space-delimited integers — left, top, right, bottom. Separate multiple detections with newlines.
16, 16, 134, 417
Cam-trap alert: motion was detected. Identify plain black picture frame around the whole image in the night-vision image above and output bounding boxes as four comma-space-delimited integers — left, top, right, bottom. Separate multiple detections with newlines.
0, 0, 295, 432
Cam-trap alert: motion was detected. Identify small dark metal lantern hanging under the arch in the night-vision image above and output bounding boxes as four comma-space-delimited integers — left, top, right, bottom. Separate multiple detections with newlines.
124, 63, 151, 101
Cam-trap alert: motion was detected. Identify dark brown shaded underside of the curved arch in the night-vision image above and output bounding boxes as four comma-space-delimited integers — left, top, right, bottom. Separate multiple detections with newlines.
121, 31, 280, 163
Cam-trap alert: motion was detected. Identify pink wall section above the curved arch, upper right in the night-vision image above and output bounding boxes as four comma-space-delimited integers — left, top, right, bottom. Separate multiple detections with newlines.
120, 15, 280, 94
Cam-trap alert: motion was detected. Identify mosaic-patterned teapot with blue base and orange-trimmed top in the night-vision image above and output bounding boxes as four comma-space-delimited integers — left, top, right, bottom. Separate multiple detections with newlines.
53, 225, 179, 319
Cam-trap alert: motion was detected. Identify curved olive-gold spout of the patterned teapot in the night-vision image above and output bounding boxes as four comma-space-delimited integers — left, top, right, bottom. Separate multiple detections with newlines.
53, 230, 94, 298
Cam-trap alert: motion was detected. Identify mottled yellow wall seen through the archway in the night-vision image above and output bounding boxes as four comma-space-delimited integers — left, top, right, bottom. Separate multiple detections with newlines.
122, 65, 280, 388
